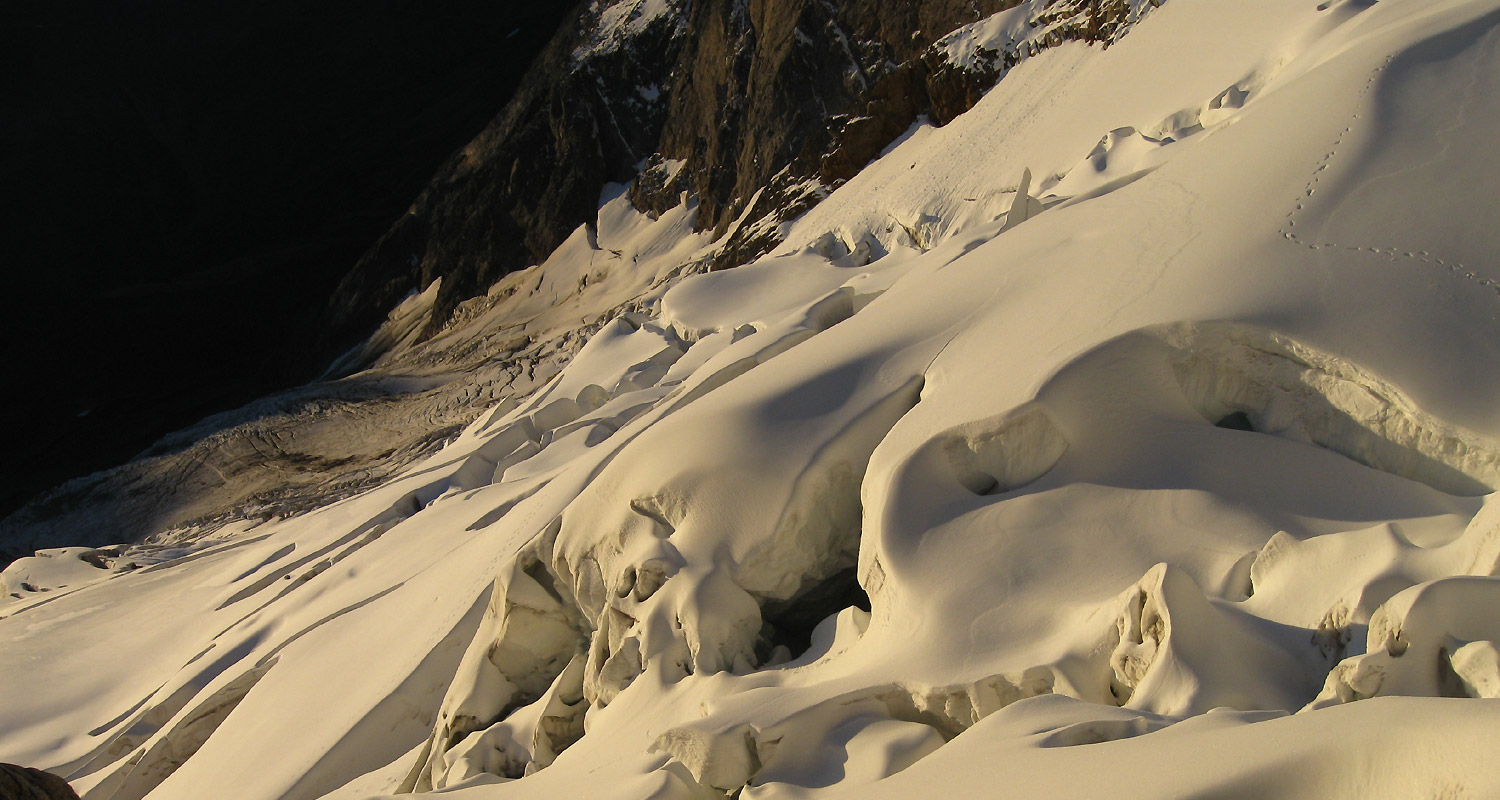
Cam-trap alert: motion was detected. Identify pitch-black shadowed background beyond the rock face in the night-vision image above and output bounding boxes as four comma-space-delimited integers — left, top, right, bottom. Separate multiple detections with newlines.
0, 0, 573, 516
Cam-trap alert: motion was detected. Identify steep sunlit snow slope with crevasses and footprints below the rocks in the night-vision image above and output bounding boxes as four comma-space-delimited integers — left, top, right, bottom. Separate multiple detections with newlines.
14, 0, 1500, 800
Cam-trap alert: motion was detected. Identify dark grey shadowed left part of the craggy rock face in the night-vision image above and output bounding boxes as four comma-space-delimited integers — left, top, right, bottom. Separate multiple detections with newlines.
330, 0, 686, 355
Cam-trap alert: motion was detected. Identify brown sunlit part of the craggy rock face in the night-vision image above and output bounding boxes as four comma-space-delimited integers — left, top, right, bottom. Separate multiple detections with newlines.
645, 0, 1017, 230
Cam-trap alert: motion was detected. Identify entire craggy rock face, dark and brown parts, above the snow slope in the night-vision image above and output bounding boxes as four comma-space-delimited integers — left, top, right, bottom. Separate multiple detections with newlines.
330, 0, 1155, 368
